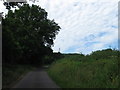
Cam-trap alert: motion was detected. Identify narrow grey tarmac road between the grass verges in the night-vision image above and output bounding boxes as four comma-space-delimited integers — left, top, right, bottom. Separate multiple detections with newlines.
13, 68, 60, 88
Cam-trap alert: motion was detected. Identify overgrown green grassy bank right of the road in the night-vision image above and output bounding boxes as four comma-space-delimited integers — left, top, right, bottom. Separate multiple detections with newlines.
48, 50, 119, 88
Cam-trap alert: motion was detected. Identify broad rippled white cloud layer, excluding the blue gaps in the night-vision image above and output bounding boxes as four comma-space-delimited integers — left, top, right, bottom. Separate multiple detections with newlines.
47, 2, 118, 52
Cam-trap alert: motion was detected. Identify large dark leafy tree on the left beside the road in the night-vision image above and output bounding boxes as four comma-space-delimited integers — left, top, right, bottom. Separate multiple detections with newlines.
2, 4, 60, 63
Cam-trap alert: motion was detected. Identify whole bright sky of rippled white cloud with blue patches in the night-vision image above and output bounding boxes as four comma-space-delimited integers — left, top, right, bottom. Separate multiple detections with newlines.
0, 0, 118, 54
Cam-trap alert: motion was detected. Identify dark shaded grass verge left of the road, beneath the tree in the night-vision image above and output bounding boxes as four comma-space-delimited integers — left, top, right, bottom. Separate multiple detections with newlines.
2, 64, 35, 88
